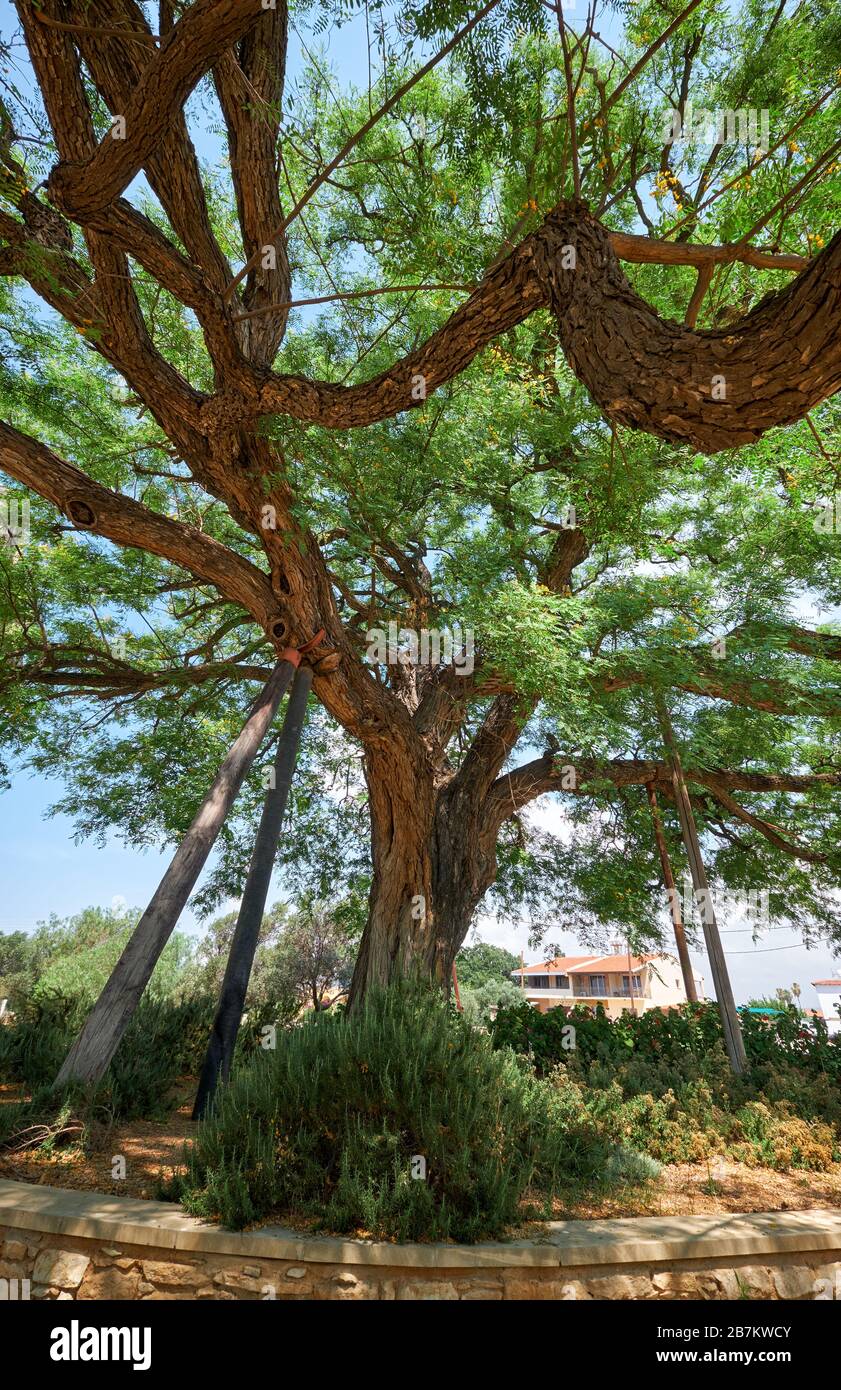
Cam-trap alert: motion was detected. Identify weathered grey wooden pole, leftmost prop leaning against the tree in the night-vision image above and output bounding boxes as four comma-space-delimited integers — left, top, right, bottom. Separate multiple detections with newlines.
56, 660, 295, 1086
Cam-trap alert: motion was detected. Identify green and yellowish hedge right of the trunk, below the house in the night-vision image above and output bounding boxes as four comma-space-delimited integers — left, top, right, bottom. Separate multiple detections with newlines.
493, 1004, 841, 1170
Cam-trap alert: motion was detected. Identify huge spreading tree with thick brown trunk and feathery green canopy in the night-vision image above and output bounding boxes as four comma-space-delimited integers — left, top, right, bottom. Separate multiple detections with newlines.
0, 0, 841, 1023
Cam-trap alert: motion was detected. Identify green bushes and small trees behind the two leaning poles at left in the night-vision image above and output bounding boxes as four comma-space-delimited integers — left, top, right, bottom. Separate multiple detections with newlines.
0, 901, 359, 1129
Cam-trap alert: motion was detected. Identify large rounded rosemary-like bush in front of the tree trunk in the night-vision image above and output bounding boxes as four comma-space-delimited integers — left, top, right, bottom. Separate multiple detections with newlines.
167, 986, 609, 1241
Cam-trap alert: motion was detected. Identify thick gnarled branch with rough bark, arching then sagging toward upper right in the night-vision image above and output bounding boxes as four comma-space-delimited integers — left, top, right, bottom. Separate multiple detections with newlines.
254, 204, 841, 453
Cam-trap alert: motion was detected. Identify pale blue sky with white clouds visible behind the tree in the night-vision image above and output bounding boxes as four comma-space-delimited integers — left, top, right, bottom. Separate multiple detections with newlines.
0, 0, 838, 1006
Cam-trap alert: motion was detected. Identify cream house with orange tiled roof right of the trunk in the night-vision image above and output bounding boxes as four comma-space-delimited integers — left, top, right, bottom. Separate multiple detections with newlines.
512, 952, 705, 1017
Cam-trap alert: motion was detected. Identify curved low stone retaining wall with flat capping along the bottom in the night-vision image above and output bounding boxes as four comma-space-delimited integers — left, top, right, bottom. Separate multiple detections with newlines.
0, 1182, 841, 1300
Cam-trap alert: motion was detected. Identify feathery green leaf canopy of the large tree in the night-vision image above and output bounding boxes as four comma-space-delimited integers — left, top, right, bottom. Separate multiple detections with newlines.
0, 0, 841, 956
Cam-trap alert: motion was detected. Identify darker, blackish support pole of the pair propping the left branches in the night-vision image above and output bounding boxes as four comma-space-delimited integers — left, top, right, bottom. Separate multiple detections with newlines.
193, 666, 313, 1120
